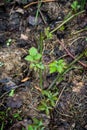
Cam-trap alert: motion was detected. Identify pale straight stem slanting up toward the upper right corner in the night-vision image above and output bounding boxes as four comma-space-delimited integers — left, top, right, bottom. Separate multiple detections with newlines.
50, 10, 85, 33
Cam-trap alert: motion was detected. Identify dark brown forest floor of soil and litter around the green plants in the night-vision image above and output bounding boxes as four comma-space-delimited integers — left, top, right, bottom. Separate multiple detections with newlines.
0, 0, 87, 130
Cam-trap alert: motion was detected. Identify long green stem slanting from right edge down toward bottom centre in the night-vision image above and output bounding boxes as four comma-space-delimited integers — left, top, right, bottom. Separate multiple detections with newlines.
48, 49, 87, 89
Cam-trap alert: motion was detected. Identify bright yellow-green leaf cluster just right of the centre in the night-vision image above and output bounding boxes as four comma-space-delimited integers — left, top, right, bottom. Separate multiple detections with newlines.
49, 59, 66, 73
